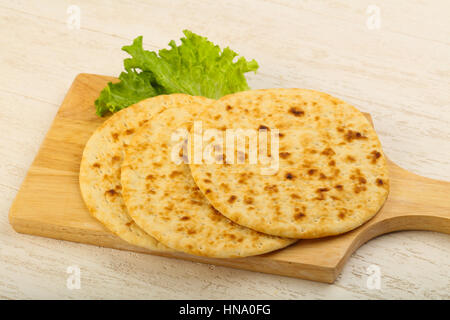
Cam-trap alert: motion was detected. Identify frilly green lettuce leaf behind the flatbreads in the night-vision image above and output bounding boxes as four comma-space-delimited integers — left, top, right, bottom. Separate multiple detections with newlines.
95, 30, 258, 116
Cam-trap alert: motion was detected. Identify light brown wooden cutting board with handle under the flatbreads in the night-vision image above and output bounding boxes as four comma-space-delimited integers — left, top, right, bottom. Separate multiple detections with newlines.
9, 74, 450, 283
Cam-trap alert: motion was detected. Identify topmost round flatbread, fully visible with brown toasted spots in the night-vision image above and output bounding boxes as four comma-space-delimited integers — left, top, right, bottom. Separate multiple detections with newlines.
190, 89, 389, 239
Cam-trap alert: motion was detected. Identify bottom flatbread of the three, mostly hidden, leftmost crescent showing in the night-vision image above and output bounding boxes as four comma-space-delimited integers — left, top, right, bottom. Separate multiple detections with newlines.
79, 94, 211, 251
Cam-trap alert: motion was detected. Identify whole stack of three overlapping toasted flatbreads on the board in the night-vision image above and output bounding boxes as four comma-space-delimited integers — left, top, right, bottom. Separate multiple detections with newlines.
80, 89, 389, 258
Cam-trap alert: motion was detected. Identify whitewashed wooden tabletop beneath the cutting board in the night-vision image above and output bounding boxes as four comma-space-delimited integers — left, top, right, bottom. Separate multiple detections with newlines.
0, 0, 450, 299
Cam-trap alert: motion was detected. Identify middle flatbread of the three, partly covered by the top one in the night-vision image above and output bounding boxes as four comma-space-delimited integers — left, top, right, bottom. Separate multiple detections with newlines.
122, 104, 295, 258
